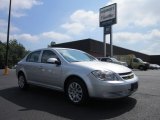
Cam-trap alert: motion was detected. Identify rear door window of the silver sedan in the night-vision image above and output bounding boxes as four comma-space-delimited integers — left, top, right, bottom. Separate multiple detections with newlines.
26, 51, 41, 62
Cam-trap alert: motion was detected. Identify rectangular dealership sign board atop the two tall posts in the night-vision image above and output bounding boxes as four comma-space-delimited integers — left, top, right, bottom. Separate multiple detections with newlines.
99, 3, 117, 27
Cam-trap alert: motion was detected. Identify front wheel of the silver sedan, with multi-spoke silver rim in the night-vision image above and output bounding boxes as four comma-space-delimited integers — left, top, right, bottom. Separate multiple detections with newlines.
65, 77, 88, 105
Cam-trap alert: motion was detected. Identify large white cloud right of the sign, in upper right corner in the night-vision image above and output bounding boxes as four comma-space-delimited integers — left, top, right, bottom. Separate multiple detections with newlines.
108, 0, 160, 29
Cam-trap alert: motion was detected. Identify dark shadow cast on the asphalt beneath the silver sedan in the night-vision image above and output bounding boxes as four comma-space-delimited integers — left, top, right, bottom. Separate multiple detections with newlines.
0, 86, 137, 120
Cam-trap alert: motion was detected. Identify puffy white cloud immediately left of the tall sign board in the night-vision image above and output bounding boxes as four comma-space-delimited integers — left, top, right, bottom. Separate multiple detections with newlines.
61, 10, 98, 35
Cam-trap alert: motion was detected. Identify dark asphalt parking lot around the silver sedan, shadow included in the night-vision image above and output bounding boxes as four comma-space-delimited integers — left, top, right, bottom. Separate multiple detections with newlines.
0, 70, 160, 120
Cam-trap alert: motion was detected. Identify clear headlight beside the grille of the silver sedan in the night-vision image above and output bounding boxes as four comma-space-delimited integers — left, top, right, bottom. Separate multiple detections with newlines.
92, 70, 122, 81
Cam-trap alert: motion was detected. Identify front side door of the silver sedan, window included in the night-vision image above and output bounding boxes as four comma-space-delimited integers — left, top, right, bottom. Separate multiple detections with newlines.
39, 50, 62, 87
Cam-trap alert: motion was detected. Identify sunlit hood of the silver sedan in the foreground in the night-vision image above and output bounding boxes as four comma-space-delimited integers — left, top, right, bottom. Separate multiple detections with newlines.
72, 61, 131, 73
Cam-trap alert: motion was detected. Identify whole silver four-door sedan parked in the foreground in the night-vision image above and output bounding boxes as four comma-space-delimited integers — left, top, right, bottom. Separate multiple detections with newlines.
16, 48, 138, 104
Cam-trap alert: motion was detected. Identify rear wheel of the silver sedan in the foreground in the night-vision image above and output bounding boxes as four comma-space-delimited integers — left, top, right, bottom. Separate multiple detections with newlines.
18, 73, 28, 90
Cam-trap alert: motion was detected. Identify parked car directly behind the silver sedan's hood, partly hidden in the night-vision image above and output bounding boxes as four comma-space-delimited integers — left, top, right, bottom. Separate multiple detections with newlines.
97, 57, 128, 67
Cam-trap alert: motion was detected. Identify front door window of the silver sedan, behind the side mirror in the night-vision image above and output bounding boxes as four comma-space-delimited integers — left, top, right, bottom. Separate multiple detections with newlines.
41, 50, 57, 63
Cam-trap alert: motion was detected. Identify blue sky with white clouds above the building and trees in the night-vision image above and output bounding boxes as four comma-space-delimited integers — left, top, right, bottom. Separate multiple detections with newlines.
0, 0, 160, 55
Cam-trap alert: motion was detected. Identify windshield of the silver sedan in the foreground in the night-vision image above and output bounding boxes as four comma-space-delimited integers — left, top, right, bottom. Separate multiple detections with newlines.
58, 49, 97, 62
